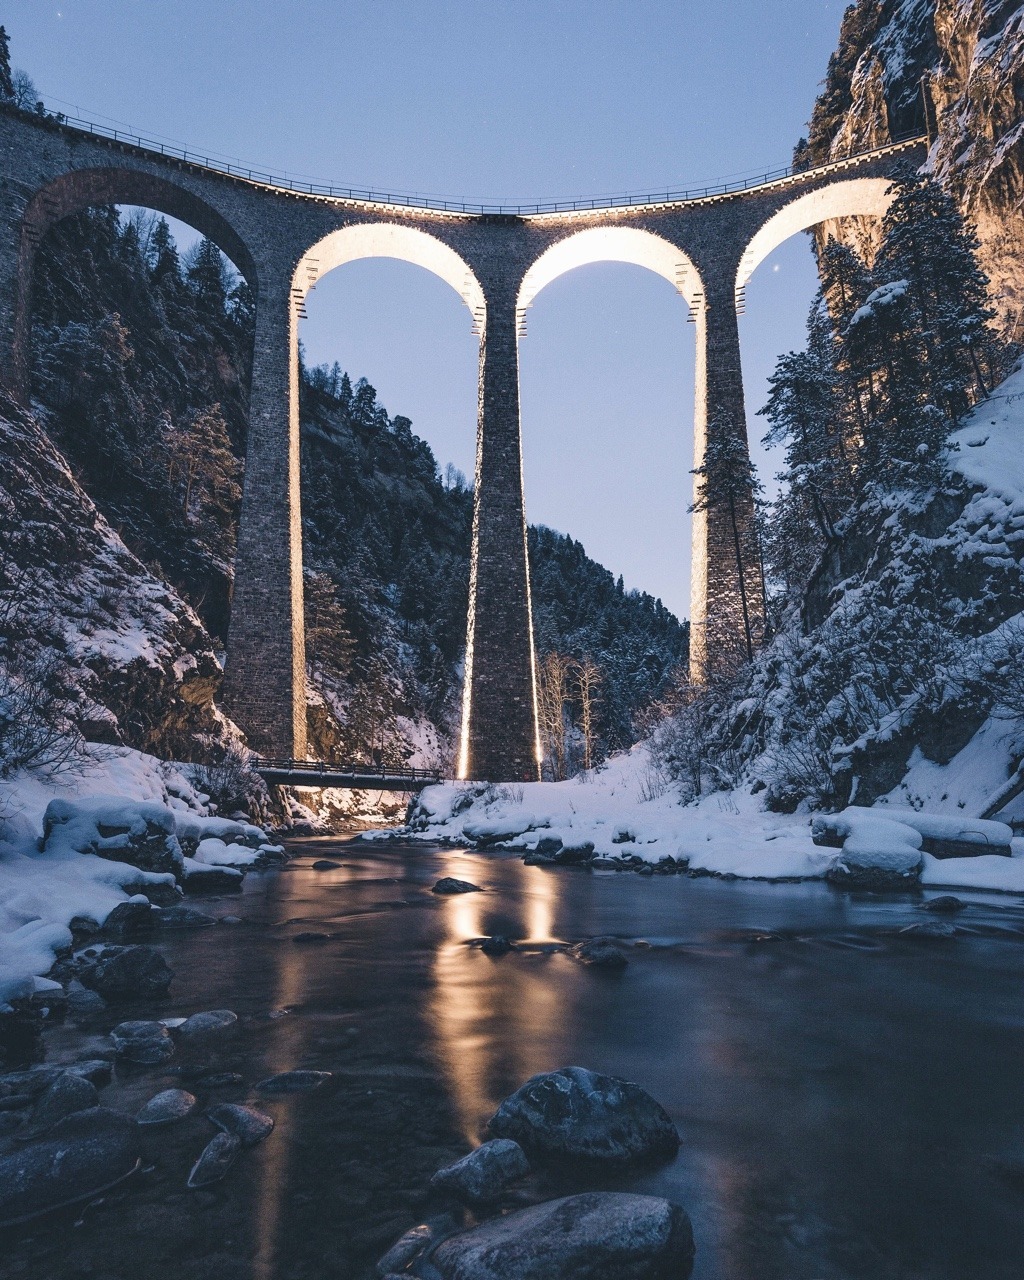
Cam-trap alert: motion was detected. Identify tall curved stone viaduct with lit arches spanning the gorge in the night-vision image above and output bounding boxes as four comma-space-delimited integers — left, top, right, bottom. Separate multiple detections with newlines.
0, 109, 925, 781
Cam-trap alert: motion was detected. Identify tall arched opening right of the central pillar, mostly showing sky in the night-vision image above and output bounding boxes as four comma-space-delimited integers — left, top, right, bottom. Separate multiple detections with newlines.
518, 227, 703, 774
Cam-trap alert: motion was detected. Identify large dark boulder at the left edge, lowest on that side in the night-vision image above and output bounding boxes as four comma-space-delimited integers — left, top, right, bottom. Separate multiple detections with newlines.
0, 1107, 138, 1226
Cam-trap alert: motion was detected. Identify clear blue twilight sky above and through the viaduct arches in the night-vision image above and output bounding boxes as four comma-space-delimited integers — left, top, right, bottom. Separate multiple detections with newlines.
0, 0, 845, 614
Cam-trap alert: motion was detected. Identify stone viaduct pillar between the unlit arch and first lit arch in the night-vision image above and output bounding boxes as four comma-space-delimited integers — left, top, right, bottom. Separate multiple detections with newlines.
224, 280, 306, 759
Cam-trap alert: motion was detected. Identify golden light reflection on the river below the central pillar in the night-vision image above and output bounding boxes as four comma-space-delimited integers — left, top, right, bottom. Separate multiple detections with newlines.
429, 868, 564, 1144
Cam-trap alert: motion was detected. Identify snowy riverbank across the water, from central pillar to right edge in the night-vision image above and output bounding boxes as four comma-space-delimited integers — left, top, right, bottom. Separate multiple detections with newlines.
362, 745, 1024, 892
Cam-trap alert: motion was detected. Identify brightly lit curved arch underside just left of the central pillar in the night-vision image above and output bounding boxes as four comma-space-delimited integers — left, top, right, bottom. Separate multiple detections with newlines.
292, 223, 486, 330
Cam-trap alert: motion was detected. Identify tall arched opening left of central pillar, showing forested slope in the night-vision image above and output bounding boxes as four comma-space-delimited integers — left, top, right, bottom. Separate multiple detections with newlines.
285, 224, 484, 768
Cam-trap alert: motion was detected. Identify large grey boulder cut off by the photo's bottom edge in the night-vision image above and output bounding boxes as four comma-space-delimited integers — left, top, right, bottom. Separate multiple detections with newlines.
430, 1192, 694, 1280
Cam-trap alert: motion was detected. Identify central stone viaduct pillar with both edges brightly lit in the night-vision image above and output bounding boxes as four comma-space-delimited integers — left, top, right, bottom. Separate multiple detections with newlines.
458, 287, 540, 782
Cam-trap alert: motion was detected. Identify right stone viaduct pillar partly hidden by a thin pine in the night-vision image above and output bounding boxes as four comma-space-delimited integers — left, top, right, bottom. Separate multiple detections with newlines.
690, 280, 765, 682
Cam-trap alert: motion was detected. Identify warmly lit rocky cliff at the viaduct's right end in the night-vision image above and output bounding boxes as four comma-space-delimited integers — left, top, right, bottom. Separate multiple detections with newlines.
797, 0, 1024, 340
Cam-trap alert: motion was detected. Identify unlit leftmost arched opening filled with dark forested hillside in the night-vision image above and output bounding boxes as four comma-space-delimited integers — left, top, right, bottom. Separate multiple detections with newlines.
26, 179, 256, 643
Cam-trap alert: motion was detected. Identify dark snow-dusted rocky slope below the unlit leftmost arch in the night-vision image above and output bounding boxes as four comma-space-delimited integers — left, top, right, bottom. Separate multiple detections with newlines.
0, 393, 232, 759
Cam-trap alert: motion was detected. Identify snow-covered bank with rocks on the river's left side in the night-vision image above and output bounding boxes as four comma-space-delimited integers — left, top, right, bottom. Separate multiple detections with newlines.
0, 746, 280, 1006
